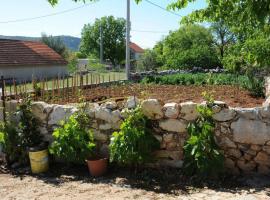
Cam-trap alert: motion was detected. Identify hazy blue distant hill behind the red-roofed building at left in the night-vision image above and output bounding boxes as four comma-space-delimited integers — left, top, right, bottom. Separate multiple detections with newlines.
0, 35, 81, 51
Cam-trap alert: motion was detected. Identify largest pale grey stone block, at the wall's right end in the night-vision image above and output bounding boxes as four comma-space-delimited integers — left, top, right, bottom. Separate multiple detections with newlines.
231, 118, 270, 145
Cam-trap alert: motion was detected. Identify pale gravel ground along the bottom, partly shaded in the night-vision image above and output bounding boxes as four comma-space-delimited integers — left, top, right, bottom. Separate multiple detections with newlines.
0, 169, 270, 200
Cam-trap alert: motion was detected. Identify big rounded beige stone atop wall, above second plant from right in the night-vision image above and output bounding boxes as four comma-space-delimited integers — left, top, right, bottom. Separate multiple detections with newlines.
141, 99, 164, 119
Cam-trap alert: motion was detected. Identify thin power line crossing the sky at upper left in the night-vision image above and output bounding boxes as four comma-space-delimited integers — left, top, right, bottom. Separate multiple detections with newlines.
0, 2, 97, 24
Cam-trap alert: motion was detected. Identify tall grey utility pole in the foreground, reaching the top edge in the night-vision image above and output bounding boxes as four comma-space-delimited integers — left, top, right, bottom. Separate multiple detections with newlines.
126, 0, 130, 80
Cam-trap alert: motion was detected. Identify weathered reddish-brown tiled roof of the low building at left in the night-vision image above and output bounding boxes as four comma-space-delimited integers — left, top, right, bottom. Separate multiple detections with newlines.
0, 39, 67, 67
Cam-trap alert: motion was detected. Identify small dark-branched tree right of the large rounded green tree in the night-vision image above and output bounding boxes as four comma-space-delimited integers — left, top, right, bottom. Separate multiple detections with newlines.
210, 21, 236, 60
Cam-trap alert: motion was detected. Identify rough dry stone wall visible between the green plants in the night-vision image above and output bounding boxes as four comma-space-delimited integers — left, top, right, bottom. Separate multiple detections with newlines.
0, 76, 270, 174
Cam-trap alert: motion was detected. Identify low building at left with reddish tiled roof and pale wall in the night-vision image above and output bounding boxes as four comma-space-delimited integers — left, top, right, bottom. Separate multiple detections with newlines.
0, 39, 68, 81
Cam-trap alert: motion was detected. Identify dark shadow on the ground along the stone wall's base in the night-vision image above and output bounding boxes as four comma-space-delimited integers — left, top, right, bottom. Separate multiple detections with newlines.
5, 164, 270, 196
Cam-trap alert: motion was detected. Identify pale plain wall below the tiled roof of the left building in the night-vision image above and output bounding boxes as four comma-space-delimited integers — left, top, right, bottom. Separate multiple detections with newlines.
0, 65, 68, 81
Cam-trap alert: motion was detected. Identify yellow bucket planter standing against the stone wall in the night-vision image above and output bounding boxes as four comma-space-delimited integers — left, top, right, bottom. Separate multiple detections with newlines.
29, 149, 49, 174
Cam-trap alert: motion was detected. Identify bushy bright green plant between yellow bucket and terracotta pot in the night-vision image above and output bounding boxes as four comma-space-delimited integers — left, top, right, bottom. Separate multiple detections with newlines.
49, 110, 95, 164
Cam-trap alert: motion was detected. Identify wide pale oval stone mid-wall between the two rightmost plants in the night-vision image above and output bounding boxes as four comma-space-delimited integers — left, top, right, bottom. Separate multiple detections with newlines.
159, 119, 187, 133
